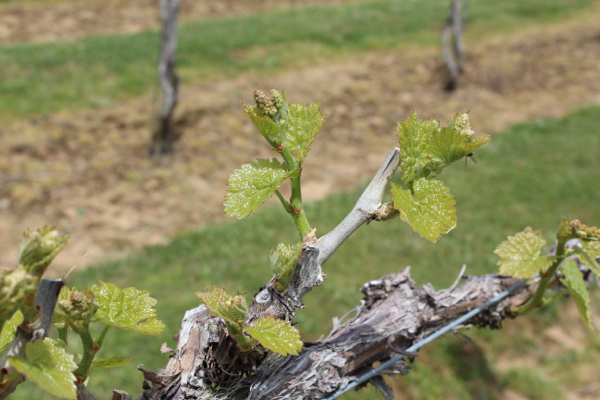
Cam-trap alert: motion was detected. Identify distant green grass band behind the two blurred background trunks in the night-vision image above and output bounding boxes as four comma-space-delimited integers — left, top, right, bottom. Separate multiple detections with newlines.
0, 0, 594, 120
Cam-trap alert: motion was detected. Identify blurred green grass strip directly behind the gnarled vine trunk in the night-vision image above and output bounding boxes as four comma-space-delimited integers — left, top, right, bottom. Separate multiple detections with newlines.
9, 107, 600, 400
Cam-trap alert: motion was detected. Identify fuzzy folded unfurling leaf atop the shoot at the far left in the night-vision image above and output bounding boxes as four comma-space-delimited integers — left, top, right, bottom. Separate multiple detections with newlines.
19, 226, 68, 277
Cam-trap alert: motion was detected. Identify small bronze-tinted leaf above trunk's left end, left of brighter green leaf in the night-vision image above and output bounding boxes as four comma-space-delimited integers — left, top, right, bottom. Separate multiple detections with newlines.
194, 285, 248, 324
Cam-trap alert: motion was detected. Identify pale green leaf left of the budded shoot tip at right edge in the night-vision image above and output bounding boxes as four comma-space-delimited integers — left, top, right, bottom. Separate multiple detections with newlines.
494, 227, 554, 279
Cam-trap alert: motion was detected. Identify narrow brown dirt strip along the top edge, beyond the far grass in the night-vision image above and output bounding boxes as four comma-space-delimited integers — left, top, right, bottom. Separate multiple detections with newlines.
0, 0, 350, 45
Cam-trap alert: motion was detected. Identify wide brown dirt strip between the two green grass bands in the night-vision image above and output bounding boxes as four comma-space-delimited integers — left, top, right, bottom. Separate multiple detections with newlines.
0, 13, 600, 276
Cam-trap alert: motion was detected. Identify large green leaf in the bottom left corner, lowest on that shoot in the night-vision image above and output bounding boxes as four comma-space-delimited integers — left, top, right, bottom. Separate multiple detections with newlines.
7, 338, 77, 399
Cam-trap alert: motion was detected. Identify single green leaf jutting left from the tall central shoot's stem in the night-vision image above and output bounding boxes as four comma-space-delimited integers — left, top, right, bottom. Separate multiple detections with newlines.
225, 158, 298, 219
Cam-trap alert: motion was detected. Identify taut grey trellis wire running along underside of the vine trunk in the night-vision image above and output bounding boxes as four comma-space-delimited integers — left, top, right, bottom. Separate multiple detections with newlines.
323, 280, 526, 400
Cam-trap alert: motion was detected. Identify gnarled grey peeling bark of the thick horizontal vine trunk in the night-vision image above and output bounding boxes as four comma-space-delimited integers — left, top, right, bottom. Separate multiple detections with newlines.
136, 268, 535, 400
